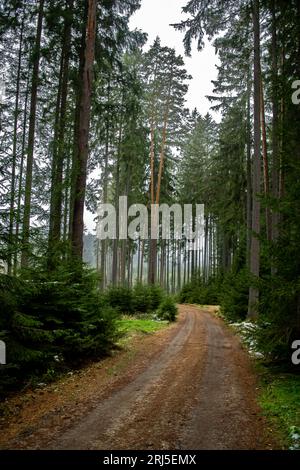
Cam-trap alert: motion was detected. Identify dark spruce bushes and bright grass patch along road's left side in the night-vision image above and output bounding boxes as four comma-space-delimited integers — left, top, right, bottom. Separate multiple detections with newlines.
0, 266, 177, 396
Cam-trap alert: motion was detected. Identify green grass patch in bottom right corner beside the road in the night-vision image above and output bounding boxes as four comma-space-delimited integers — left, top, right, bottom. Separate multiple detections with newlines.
259, 366, 300, 450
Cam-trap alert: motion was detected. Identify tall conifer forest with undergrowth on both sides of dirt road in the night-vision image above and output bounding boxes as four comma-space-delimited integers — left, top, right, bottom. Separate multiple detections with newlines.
0, 0, 300, 456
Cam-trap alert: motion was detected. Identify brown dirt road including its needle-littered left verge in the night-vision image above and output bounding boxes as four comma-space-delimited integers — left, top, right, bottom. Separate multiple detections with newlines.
2, 306, 272, 450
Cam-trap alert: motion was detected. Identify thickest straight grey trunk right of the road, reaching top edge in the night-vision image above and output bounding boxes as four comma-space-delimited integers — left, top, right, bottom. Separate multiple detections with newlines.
248, 0, 261, 319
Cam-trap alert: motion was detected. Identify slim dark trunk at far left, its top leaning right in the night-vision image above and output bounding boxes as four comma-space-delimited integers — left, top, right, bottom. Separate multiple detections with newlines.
21, 0, 44, 268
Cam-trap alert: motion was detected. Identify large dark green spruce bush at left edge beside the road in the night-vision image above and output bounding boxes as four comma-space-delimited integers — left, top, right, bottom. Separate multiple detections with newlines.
0, 268, 117, 391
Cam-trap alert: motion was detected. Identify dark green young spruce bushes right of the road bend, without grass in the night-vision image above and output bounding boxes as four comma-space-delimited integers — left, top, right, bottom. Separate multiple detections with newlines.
177, 270, 300, 366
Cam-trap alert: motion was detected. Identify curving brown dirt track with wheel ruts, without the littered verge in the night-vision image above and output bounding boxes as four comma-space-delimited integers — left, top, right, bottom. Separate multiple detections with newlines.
50, 306, 266, 450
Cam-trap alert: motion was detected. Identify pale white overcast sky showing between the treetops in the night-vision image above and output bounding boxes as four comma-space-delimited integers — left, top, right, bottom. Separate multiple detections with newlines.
85, 0, 219, 232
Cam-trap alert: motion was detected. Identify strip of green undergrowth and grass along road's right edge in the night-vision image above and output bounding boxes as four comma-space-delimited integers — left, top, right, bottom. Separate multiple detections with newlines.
178, 278, 300, 450
